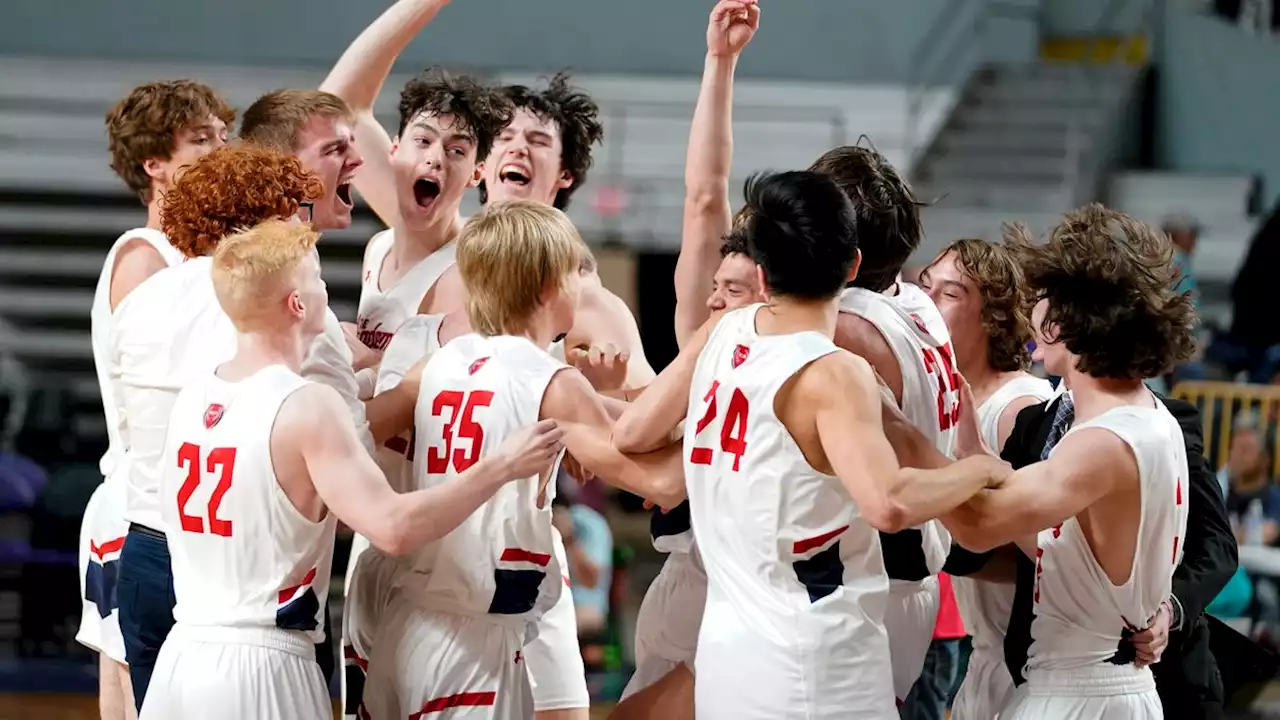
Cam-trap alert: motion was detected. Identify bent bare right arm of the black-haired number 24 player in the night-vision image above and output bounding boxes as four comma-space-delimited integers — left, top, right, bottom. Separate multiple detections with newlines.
808, 352, 1006, 533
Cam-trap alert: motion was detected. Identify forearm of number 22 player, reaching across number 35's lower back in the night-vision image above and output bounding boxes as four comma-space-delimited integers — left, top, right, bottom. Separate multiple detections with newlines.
384, 457, 513, 555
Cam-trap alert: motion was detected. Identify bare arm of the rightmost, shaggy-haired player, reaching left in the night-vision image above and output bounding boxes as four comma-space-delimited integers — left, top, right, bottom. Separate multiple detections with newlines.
942, 428, 1138, 552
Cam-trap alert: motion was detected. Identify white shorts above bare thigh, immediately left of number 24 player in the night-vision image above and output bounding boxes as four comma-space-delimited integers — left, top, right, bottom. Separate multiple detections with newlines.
622, 551, 707, 700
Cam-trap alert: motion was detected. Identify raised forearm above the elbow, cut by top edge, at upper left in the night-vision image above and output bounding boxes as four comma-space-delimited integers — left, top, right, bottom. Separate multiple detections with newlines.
320, 0, 448, 113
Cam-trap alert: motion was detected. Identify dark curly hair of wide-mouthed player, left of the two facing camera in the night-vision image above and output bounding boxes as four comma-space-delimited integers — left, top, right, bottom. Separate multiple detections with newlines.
399, 68, 516, 161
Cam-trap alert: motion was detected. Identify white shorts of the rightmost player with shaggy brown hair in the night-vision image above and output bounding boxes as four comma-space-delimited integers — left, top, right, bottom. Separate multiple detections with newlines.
998, 665, 1165, 720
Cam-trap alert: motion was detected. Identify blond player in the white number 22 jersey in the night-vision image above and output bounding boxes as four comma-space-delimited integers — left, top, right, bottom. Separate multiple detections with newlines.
135, 220, 562, 720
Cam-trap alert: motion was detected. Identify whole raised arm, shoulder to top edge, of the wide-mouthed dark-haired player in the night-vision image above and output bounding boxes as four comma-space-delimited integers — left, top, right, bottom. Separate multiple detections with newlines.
320, 0, 449, 227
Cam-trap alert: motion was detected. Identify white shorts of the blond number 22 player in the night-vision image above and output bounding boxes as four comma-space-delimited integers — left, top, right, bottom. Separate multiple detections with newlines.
140, 625, 333, 720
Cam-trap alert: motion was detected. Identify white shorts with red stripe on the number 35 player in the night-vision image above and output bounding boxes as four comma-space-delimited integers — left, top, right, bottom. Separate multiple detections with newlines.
362, 600, 534, 720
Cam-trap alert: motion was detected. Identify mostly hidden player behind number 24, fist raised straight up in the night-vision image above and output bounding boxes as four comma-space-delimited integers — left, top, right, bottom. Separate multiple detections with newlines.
616, 0, 764, 720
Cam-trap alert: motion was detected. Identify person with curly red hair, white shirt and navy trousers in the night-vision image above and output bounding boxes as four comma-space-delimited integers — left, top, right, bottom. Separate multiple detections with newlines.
113, 146, 416, 703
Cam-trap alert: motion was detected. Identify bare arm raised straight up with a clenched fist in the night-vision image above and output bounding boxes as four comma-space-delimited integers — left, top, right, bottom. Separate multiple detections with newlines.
676, 0, 760, 346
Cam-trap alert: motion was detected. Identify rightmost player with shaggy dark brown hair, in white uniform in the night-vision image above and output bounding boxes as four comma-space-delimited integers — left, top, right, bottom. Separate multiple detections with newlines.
946, 205, 1194, 720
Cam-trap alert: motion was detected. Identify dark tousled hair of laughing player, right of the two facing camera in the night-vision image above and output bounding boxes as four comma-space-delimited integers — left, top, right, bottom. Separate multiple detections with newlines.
479, 73, 604, 210
